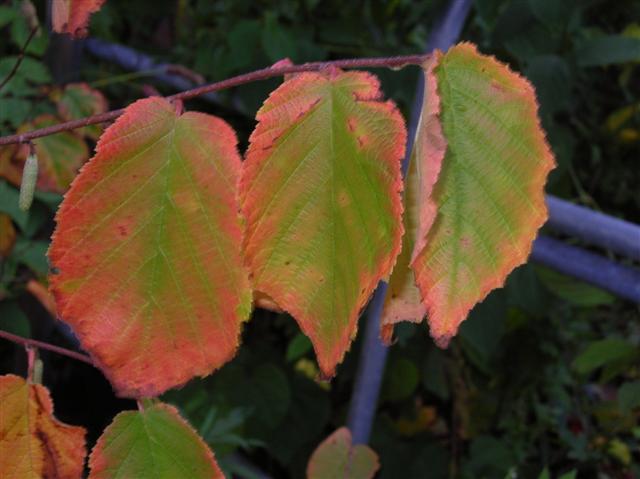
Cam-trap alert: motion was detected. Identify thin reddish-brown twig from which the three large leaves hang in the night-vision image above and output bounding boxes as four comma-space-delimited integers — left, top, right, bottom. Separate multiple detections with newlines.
0, 55, 429, 146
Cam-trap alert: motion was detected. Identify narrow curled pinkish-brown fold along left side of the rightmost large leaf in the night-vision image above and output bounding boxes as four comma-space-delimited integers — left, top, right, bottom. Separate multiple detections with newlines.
380, 51, 447, 344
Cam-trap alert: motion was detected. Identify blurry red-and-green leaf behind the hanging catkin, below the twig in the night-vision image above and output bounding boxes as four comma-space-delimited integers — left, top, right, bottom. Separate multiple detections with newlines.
15, 115, 89, 193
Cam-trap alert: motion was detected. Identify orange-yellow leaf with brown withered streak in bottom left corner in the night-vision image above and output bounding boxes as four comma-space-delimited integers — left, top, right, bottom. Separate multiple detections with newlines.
0, 374, 86, 479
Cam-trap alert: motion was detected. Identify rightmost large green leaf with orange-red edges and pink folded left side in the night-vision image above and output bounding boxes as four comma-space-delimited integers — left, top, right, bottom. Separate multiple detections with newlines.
412, 43, 554, 346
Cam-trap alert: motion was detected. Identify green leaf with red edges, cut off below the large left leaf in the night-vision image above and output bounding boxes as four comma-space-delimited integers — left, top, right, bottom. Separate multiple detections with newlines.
89, 404, 224, 479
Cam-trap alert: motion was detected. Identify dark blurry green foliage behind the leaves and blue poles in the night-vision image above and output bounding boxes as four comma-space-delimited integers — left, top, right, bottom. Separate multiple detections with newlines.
0, 0, 640, 478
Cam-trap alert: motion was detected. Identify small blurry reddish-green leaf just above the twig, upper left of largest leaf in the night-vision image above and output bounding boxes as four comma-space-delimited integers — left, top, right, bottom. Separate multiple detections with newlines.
49, 83, 109, 140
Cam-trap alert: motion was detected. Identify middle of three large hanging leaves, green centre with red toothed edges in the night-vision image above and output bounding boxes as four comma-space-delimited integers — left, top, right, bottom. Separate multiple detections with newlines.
240, 70, 406, 376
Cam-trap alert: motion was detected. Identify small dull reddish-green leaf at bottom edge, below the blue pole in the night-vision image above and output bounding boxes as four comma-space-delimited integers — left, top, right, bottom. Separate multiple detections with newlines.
307, 427, 380, 479
